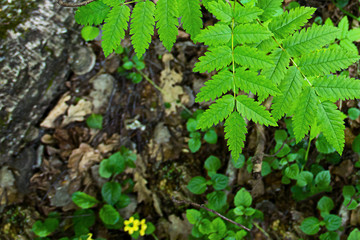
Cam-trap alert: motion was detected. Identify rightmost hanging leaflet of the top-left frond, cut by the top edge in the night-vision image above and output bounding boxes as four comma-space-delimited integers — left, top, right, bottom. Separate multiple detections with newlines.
178, 0, 202, 39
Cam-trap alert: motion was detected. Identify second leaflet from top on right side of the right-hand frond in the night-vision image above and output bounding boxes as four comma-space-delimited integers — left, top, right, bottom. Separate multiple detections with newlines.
283, 25, 340, 57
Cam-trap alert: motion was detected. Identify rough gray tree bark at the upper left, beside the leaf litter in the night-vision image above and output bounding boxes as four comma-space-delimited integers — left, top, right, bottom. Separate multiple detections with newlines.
0, 0, 80, 165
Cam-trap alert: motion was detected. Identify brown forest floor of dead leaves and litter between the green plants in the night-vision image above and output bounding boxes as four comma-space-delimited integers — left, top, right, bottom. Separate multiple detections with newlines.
0, 0, 360, 240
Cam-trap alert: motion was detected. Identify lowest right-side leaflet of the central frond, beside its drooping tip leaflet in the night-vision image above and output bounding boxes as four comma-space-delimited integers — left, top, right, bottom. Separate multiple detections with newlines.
236, 95, 277, 126
